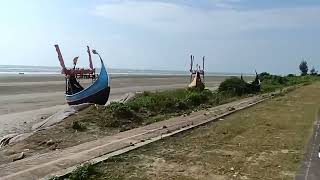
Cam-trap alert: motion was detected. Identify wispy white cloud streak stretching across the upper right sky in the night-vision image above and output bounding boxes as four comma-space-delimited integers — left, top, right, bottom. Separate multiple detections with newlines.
94, 0, 320, 33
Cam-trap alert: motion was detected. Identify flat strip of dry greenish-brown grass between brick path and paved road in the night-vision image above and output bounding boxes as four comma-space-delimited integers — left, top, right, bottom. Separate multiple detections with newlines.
80, 83, 320, 180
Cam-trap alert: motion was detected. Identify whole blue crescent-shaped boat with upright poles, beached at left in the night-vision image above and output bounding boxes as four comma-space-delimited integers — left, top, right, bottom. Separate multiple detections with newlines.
55, 45, 110, 105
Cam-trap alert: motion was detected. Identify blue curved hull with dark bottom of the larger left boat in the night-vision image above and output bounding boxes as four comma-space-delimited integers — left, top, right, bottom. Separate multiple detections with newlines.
65, 59, 110, 105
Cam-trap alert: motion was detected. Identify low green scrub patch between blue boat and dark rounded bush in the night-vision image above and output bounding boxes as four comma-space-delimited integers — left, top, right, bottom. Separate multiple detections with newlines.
89, 89, 239, 130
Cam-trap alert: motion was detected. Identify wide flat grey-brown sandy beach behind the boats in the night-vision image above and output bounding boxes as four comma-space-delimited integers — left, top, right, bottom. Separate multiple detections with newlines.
0, 75, 230, 137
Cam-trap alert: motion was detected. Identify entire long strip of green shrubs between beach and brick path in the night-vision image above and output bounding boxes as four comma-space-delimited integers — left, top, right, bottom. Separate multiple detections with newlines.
73, 72, 317, 131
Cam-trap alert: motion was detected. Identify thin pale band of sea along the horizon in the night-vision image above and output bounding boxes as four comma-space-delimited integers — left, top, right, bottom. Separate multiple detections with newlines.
0, 65, 253, 76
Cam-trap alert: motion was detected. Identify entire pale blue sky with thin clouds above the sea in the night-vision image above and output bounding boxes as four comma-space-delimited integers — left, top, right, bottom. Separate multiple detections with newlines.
0, 0, 320, 73
